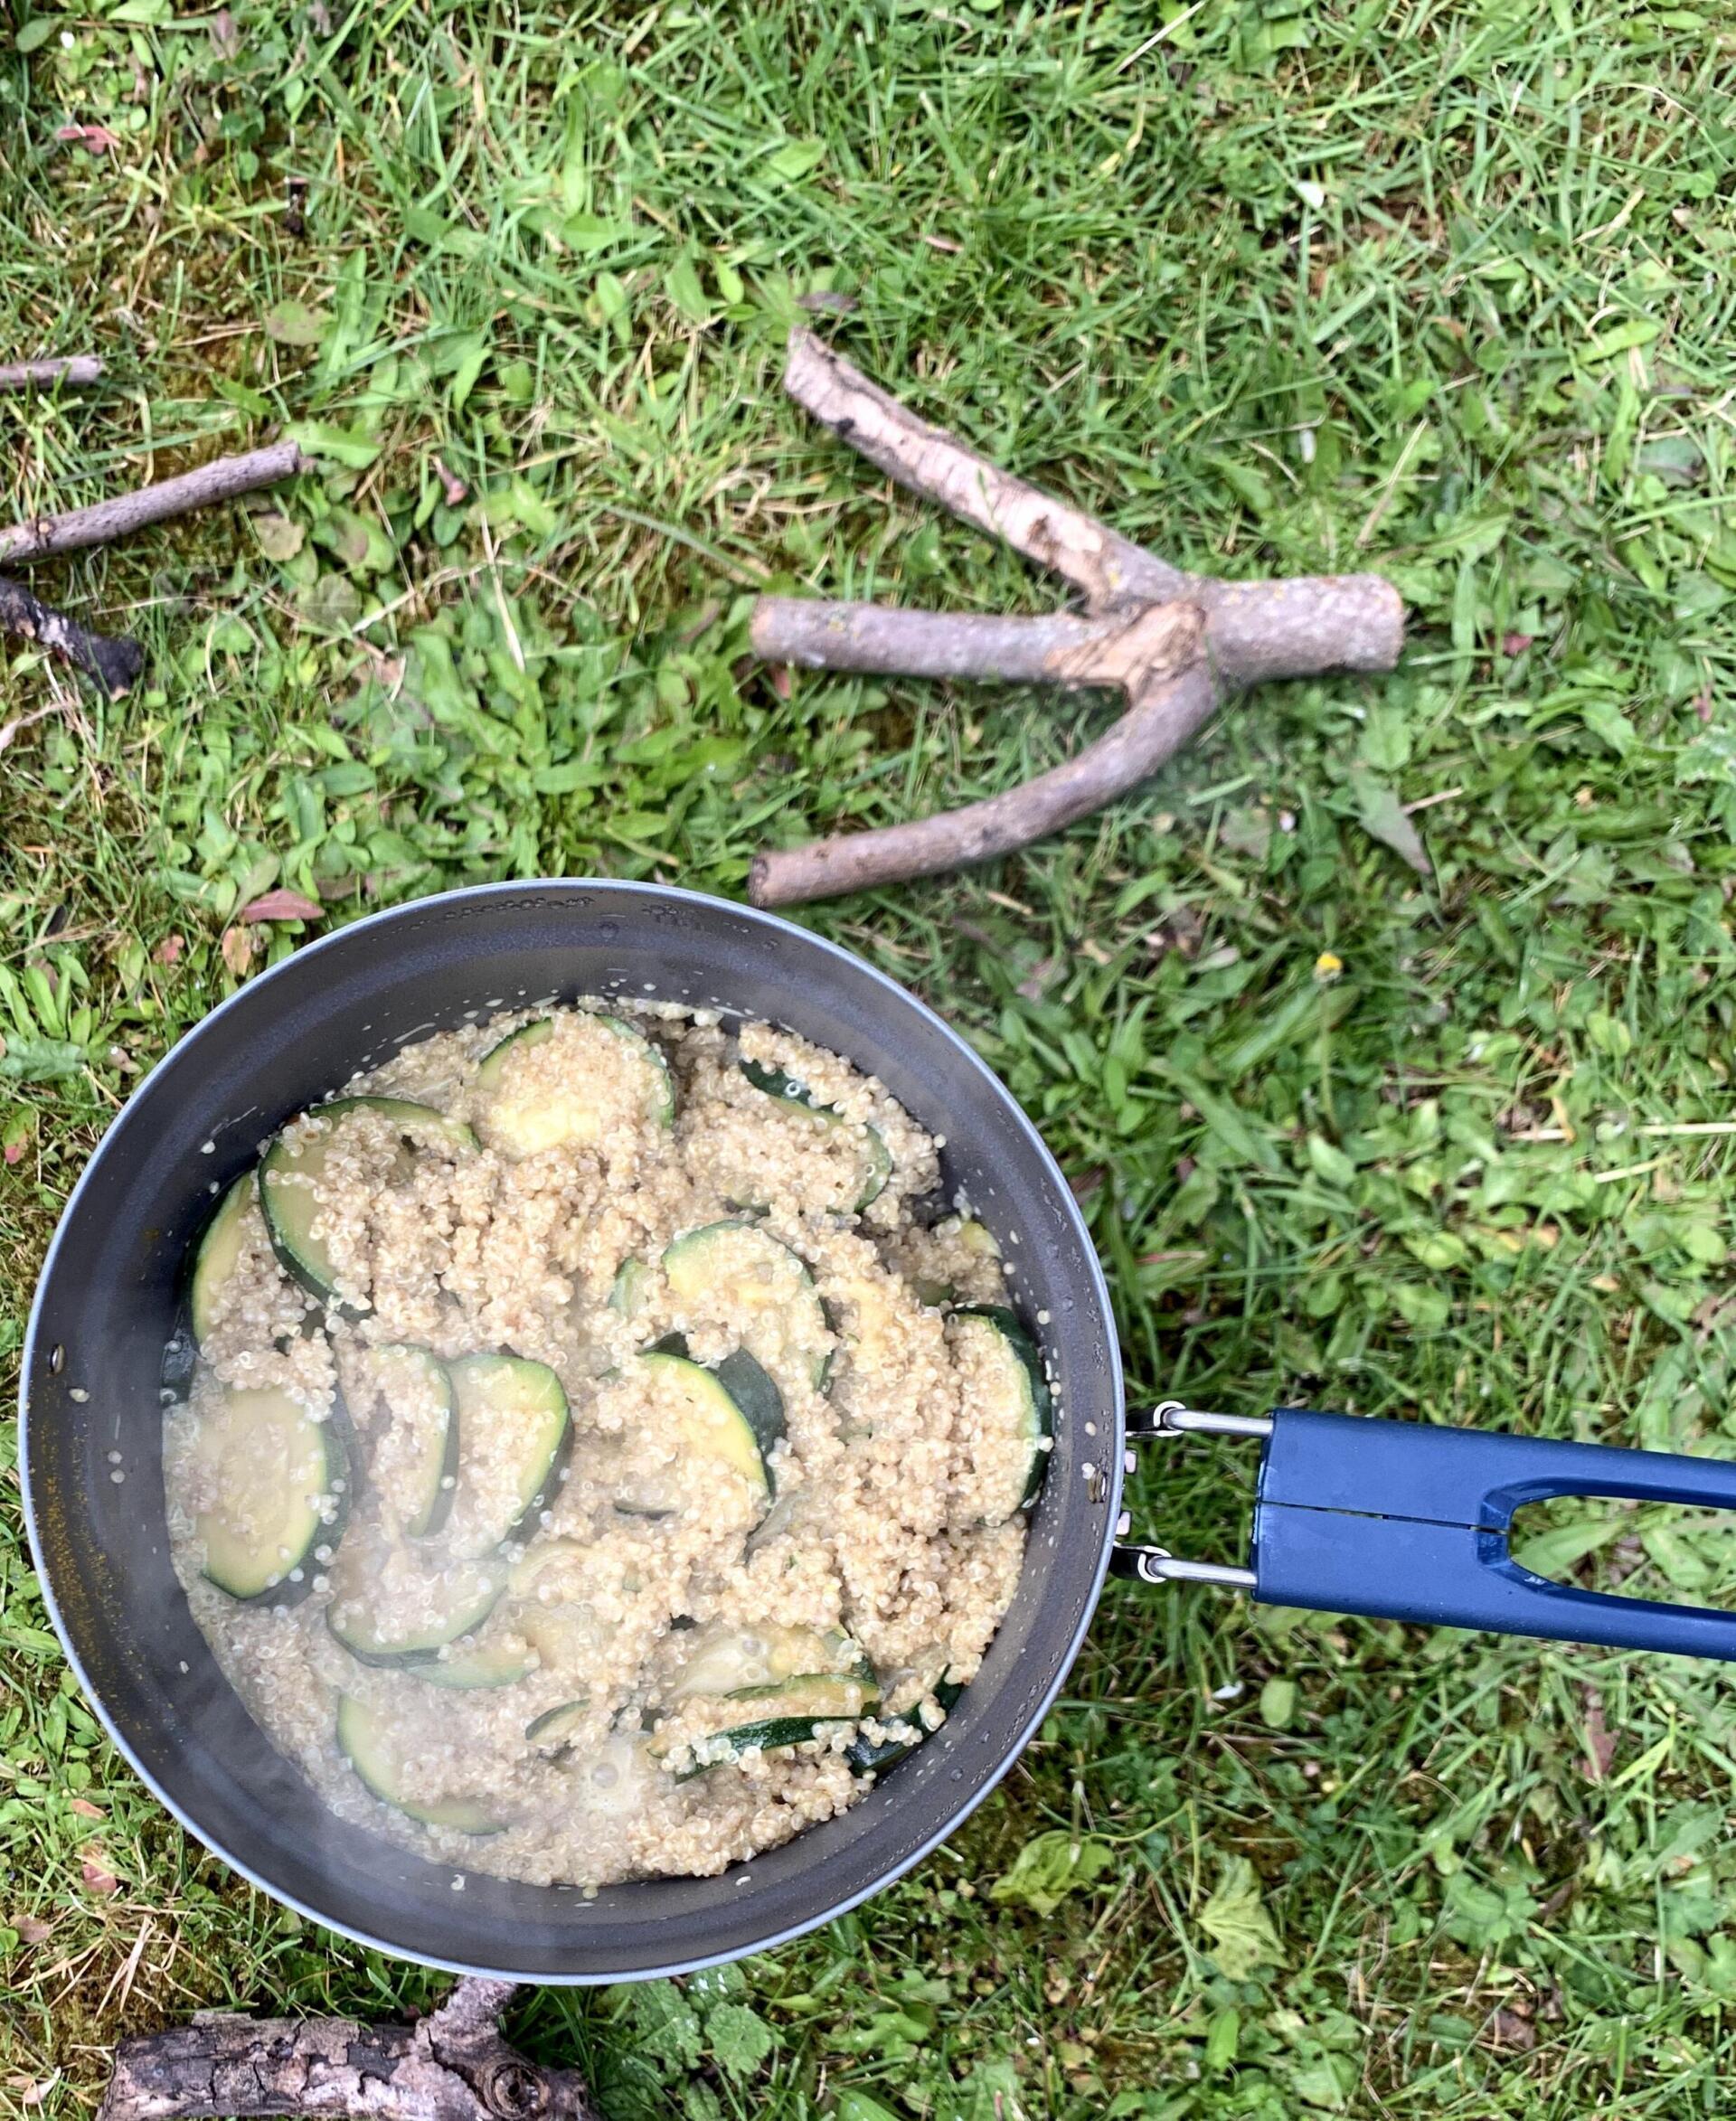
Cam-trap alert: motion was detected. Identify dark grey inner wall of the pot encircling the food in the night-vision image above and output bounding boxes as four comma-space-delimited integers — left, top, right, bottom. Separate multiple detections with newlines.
25, 882, 1120, 1981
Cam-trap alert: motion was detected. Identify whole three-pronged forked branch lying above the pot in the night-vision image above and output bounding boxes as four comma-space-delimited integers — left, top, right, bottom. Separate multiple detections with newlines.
747, 329, 1405, 906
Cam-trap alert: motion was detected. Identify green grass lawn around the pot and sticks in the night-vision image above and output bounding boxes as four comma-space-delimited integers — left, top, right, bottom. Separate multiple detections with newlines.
0, 0, 1736, 2121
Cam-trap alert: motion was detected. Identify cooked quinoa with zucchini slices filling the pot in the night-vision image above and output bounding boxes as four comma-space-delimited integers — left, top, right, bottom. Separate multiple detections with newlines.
164, 1004, 1046, 1888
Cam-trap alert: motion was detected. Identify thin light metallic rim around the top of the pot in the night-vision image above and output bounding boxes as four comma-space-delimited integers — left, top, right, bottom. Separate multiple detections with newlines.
19, 876, 1127, 1987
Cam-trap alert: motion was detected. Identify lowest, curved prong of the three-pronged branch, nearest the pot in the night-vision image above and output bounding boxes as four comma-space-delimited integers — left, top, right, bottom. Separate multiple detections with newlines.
747, 653, 1218, 906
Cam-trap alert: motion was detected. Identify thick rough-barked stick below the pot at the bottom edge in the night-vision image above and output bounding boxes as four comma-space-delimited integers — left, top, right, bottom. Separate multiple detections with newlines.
98, 1976, 597, 2121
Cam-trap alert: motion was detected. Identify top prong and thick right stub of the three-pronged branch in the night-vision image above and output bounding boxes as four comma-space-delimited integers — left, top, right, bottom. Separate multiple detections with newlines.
783, 326, 1405, 685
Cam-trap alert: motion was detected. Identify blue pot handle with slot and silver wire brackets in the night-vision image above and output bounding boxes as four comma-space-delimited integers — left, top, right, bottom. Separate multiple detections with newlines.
1112, 1404, 1736, 1661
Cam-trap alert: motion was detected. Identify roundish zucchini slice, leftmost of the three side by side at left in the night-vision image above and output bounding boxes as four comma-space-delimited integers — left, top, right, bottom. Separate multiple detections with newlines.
193, 1387, 348, 1606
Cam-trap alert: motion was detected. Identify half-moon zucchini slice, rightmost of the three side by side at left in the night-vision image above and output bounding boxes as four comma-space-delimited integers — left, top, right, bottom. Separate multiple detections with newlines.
446, 1355, 571, 1561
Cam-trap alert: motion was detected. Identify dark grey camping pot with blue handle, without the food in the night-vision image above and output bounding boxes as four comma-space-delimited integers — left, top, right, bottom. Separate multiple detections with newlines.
24, 881, 1736, 1981
